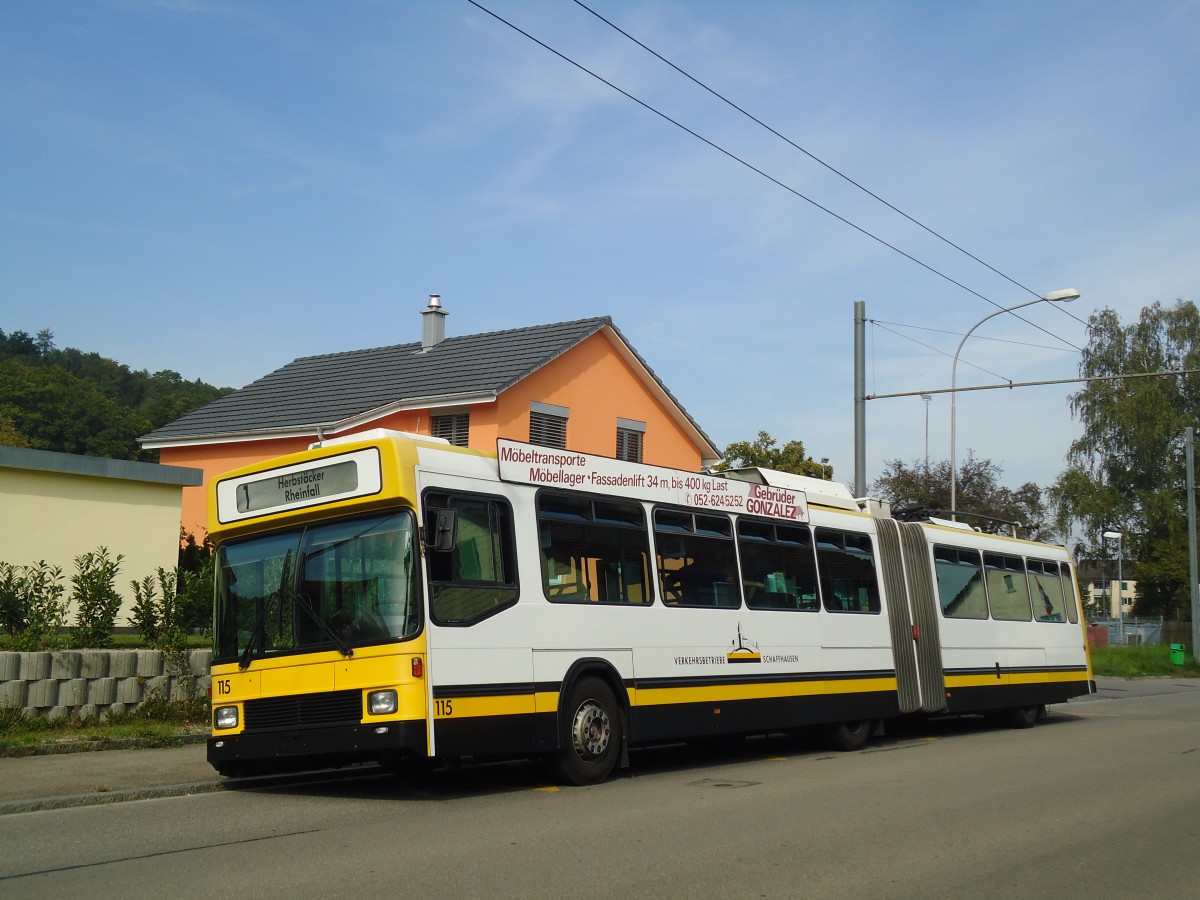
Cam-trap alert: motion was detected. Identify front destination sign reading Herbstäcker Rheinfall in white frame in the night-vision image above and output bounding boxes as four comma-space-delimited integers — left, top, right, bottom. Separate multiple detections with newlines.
217, 449, 382, 522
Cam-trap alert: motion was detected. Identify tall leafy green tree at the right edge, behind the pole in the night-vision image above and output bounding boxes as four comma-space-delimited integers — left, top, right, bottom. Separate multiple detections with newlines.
1050, 300, 1200, 619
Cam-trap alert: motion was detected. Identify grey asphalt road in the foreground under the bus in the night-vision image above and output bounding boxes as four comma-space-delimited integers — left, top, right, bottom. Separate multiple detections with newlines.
0, 679, 1200, 900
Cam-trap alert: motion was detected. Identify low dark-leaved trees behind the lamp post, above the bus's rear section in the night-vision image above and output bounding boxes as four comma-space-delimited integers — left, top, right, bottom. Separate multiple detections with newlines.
871, 454, 1051, 540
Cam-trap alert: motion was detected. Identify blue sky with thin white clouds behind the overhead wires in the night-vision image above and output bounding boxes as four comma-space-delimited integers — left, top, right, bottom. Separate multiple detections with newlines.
0, 0, 1200, 496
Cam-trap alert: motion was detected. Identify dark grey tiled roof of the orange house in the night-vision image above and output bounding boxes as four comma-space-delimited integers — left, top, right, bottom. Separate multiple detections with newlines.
140, 316, 712, 453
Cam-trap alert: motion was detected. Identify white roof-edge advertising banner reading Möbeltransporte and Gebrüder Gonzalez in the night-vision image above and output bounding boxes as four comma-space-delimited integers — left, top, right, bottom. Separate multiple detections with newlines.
497, 440, 809, 522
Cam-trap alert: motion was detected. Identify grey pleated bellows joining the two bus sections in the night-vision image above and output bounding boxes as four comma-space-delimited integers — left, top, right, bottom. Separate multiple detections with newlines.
875, 518, 946, 713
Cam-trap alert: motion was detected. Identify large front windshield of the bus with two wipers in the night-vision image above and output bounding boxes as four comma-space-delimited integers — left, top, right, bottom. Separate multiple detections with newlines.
212, 510, 421, 666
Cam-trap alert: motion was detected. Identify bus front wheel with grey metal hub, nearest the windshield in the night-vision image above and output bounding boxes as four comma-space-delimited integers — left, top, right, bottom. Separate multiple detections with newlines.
552, 678, 625, 785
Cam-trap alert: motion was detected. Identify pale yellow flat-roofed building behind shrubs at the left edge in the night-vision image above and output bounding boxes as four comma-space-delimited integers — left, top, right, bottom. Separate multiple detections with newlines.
0, 446, 202, 628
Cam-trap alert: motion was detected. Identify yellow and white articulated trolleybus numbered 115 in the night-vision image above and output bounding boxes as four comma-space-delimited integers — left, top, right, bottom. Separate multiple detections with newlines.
208, 431, 1094, 784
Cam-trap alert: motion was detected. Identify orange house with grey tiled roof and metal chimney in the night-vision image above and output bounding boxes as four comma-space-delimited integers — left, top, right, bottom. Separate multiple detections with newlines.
140, 294, 721, 535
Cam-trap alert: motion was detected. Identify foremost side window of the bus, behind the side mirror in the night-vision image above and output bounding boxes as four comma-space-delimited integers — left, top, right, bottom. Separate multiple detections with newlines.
425, 493, 517, 625
